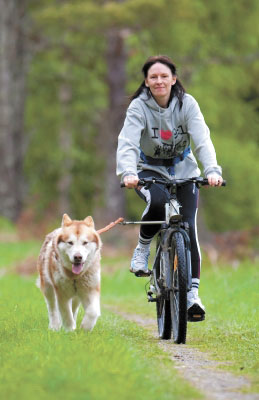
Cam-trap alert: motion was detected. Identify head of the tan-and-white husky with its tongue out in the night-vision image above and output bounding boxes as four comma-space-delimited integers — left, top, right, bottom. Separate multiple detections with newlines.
56, 214, 102, 275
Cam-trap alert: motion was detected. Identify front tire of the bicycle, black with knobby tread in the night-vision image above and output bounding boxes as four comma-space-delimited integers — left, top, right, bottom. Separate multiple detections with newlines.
170, 232, 188, 344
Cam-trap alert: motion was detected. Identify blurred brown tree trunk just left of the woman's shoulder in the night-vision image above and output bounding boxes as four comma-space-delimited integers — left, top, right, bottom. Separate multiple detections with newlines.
104, 28, 127, 221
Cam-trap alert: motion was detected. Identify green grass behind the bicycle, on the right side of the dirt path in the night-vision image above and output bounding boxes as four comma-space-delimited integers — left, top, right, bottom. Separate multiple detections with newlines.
103, 260, 259, 391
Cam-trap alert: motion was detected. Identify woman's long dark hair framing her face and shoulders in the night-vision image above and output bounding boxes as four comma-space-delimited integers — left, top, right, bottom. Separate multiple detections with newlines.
130, 55, 185, 109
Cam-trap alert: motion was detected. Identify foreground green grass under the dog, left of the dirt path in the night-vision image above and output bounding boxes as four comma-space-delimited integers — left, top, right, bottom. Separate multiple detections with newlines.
0, 275, 201, 400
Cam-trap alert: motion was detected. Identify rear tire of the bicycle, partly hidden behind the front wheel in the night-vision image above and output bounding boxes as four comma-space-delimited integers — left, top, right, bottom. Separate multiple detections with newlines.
155, 236, 172, 340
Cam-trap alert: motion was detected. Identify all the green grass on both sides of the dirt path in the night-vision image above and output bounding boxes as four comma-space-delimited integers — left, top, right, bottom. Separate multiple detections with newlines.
0, 241, 259, 400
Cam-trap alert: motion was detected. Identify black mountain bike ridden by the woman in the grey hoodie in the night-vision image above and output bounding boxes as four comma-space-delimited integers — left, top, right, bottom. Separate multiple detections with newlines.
121, 177, 226, 344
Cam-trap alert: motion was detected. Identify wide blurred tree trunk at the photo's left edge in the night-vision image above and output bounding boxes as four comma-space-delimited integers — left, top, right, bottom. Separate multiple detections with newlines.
0, 0, 26, 221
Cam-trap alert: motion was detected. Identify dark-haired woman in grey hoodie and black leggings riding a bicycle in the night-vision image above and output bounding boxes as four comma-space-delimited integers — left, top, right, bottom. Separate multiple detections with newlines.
117, 56, 223, 316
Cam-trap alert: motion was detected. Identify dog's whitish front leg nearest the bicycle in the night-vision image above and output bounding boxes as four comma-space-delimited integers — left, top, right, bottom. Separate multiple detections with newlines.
81, 290, 101, 331
